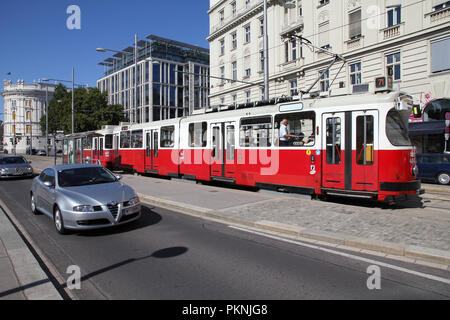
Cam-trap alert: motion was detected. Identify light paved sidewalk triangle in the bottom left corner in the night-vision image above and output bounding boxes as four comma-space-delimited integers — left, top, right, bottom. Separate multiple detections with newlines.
0, 208, 62, 300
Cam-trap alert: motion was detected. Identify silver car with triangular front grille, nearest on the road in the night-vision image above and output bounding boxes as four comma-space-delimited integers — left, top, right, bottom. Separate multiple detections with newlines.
30, 164, 141, 234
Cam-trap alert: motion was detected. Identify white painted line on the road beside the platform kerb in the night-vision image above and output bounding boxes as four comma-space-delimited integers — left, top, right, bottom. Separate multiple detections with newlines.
228, 226, 450, 285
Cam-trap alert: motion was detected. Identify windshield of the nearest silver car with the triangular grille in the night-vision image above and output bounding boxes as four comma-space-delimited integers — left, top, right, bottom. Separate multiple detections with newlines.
58, 167, 117, 188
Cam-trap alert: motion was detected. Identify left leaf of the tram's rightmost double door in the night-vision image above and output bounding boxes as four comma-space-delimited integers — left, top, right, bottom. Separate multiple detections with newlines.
322, 113, 351, 190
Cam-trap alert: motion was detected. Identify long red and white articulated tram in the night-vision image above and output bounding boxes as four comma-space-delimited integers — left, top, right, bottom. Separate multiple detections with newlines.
63, 92, 421, 201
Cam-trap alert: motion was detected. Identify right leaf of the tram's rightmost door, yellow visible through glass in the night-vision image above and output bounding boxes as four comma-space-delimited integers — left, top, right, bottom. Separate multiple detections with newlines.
352, 110, 379, 191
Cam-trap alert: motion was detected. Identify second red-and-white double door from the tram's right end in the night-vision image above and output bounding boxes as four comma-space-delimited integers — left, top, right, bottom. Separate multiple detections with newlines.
211, 122, 236, 181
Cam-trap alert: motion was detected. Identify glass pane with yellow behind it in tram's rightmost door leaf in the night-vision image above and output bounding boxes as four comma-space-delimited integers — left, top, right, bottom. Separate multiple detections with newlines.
356, 116, 374, 165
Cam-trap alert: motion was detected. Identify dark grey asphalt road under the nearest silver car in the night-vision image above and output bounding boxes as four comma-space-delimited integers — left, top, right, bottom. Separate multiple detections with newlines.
0, 180, 450, 300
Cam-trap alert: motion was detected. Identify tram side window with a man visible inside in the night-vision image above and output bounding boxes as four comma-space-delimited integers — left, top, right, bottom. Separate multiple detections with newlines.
274, 111, 316, 147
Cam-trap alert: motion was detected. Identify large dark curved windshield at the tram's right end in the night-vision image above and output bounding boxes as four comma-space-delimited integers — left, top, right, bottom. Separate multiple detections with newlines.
386, 109, 411, 146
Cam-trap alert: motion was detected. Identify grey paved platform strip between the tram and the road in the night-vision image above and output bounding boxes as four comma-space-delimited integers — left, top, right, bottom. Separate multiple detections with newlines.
23, 157, 450, 270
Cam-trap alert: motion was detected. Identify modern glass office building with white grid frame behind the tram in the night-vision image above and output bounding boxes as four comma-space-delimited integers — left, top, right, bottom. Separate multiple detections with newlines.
97, 35, 209, 123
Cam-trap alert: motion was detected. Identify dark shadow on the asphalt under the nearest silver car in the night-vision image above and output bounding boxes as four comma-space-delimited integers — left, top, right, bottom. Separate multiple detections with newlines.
73, 206, 162, 237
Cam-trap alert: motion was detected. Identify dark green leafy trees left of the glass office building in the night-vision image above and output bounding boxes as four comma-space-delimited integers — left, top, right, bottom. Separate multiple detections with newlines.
41, 84, 124, 134
